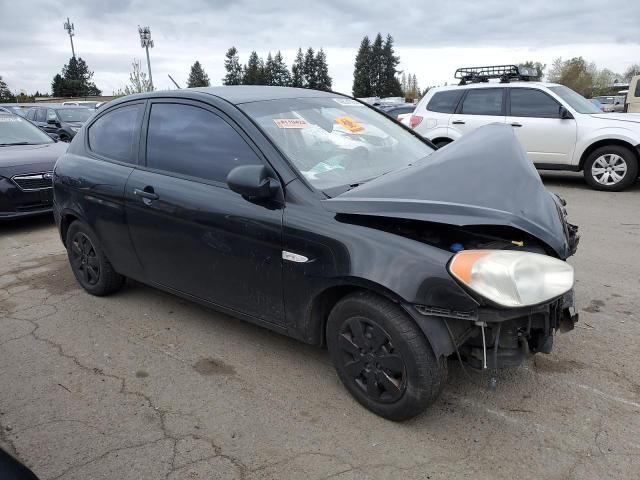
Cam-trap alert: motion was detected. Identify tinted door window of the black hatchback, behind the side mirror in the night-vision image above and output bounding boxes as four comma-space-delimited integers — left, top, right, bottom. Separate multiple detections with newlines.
147, 103, 262, 183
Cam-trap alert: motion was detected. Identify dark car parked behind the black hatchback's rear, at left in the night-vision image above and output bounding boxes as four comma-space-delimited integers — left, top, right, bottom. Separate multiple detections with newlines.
26, 105, 93, 142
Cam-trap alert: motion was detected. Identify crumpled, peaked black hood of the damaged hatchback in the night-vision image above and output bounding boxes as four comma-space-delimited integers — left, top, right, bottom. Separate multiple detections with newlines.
323, 124, 571, 258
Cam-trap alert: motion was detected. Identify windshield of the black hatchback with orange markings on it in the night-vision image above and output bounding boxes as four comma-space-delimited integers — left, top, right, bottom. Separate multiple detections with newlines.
240, 97, 434, 195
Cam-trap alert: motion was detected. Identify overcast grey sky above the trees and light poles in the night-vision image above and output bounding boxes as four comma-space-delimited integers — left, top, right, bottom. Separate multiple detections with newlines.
0, 0, 640, 94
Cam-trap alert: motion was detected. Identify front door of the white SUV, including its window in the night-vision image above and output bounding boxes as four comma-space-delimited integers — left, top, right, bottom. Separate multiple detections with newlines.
507, 87, 577, 166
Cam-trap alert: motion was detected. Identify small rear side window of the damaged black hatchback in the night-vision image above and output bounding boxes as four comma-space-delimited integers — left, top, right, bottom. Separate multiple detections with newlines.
88, 103, 144, 163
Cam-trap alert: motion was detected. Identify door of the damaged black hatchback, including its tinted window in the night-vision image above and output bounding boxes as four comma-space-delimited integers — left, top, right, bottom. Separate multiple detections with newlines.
126, 100, 284, 324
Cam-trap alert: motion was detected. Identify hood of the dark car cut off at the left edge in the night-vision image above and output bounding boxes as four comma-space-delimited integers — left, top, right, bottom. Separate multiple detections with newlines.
0, 142, 69, 177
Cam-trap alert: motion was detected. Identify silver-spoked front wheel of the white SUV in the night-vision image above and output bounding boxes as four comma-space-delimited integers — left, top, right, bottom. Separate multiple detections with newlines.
584, 145, 638, 192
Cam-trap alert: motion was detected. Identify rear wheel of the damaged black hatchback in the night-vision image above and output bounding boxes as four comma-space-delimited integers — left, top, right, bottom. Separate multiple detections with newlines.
66, 221, 124, 296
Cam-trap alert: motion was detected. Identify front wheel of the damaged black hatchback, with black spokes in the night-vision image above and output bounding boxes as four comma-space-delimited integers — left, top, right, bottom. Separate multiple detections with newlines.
327, 292, 447, 421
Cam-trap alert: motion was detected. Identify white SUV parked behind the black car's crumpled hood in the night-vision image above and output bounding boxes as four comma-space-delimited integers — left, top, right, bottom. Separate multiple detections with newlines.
409, 79, 640, 191
